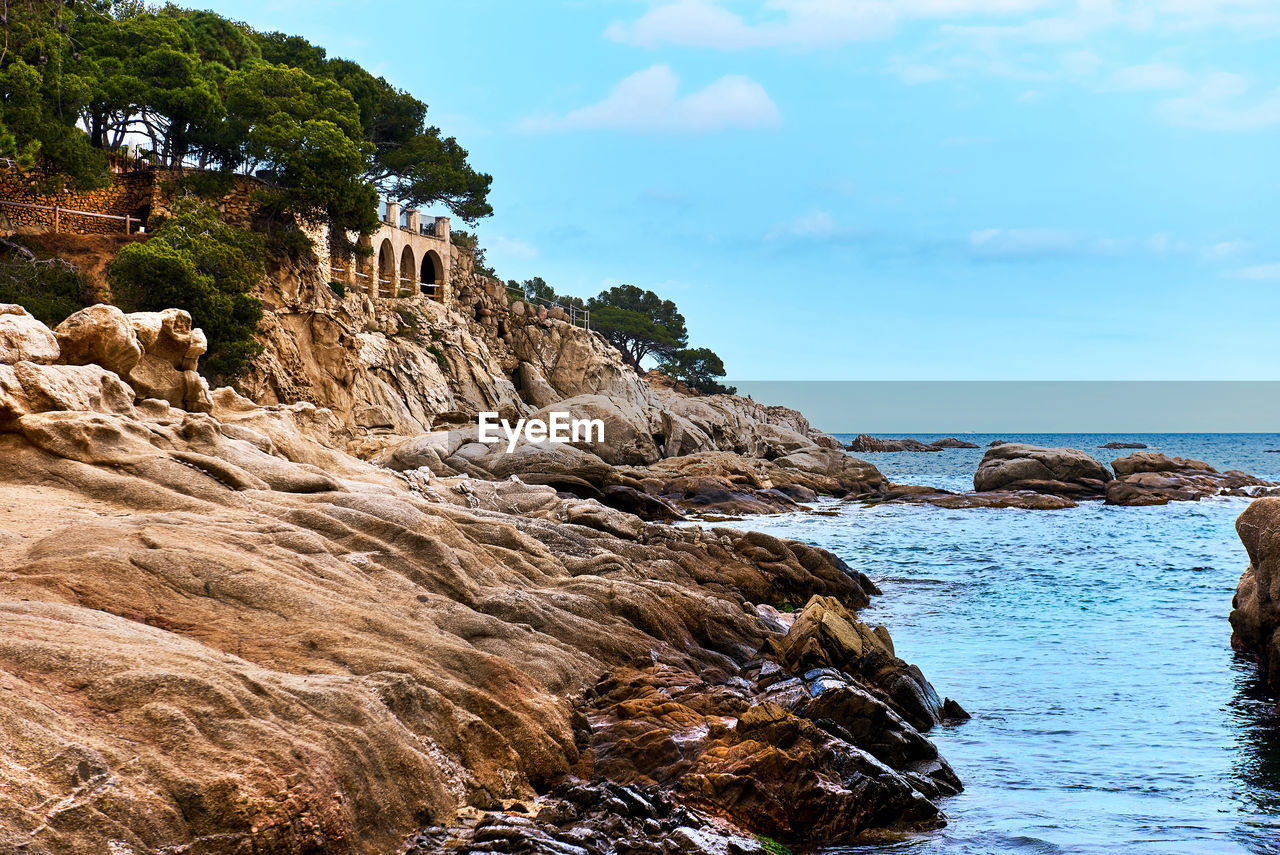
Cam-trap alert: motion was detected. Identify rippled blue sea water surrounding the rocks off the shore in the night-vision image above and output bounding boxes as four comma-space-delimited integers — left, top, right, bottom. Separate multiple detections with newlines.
735, 434, 1280, 855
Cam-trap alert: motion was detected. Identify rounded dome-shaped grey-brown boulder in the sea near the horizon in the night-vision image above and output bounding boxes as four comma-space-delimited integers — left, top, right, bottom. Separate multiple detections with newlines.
973, 443, 1111, 499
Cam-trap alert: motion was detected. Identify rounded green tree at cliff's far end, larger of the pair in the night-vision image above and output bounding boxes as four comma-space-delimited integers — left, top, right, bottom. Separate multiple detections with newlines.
588, 285, 689, 370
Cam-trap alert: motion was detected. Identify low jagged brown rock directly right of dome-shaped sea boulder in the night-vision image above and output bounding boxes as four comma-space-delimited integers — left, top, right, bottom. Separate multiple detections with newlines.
1106, 452, 1280, 506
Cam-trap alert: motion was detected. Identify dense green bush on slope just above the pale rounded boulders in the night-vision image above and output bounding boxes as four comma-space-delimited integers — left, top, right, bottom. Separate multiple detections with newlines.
106, 200, 264, 379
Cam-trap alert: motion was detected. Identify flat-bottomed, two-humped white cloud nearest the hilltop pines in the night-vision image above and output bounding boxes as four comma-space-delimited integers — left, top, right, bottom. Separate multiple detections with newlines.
521, 65, 782, 133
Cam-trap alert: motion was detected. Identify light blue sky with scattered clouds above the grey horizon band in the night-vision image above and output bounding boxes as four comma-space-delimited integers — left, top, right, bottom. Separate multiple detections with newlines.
197, 0, 1280, 380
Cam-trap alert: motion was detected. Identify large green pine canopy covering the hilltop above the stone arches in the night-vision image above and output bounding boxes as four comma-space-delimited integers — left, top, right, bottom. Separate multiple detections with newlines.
0, 0, 493, 232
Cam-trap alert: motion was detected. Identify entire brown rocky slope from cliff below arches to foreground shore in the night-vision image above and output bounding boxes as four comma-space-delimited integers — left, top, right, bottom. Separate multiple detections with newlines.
0, 250, 963, 855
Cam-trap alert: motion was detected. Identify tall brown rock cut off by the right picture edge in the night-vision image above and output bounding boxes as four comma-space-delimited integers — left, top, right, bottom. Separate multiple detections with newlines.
1231, 499, 1280, 695
